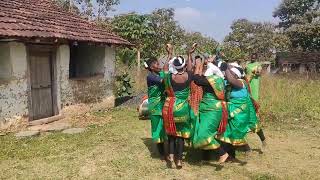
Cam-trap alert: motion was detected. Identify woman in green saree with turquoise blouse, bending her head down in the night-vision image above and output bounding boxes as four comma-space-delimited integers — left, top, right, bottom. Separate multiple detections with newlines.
217, 63, 250, 158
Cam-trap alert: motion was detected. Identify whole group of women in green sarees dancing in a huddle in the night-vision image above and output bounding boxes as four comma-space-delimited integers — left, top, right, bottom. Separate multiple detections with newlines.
144, 43, 266, 169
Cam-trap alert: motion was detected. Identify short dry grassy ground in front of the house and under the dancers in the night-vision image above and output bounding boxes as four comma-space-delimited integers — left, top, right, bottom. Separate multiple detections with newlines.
0, 108, 320, 180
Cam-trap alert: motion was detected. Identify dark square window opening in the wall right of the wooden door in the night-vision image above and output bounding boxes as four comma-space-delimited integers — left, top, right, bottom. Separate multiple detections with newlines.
69, 44, 105, 79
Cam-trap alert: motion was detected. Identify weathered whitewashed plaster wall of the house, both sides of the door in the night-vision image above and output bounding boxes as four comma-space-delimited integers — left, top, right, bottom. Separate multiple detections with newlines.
0, 42, 115, 127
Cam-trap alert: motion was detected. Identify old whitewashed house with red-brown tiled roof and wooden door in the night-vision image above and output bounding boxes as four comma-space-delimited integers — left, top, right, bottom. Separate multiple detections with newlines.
0, 0, 131, 126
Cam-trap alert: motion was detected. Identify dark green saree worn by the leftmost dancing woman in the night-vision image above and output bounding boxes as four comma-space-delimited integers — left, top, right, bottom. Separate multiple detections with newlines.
148, 72, 166, 143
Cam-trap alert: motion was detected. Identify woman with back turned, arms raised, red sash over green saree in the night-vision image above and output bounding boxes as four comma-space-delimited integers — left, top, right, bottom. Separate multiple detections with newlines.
162, 44, 196, 169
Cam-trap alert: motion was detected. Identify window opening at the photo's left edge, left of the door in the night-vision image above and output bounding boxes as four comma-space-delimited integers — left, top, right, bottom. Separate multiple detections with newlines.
0, 43, 12, 82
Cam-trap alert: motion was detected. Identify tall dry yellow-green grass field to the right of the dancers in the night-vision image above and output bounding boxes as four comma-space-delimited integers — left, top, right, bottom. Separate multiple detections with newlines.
260, 76, 320, 132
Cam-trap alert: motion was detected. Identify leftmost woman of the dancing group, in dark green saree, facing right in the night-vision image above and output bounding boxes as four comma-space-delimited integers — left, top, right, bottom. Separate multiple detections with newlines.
145, 58, 166, 158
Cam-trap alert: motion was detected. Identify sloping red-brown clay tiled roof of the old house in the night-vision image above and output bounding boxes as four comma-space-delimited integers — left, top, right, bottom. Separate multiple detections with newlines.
0, 0, 130, 45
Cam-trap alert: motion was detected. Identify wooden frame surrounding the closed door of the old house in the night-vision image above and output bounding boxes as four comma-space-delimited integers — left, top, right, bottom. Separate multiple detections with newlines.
26, 44, 59, 121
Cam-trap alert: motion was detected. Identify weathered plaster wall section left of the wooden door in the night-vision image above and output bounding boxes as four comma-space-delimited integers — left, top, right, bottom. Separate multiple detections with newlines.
0, 42, 28, 122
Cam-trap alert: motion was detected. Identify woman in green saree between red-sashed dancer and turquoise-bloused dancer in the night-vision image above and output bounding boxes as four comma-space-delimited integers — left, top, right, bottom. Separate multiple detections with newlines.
193, 59, 229, 163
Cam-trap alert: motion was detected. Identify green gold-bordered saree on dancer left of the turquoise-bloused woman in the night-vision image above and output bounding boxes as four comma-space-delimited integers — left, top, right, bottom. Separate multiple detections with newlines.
193, 76, 224, 150
